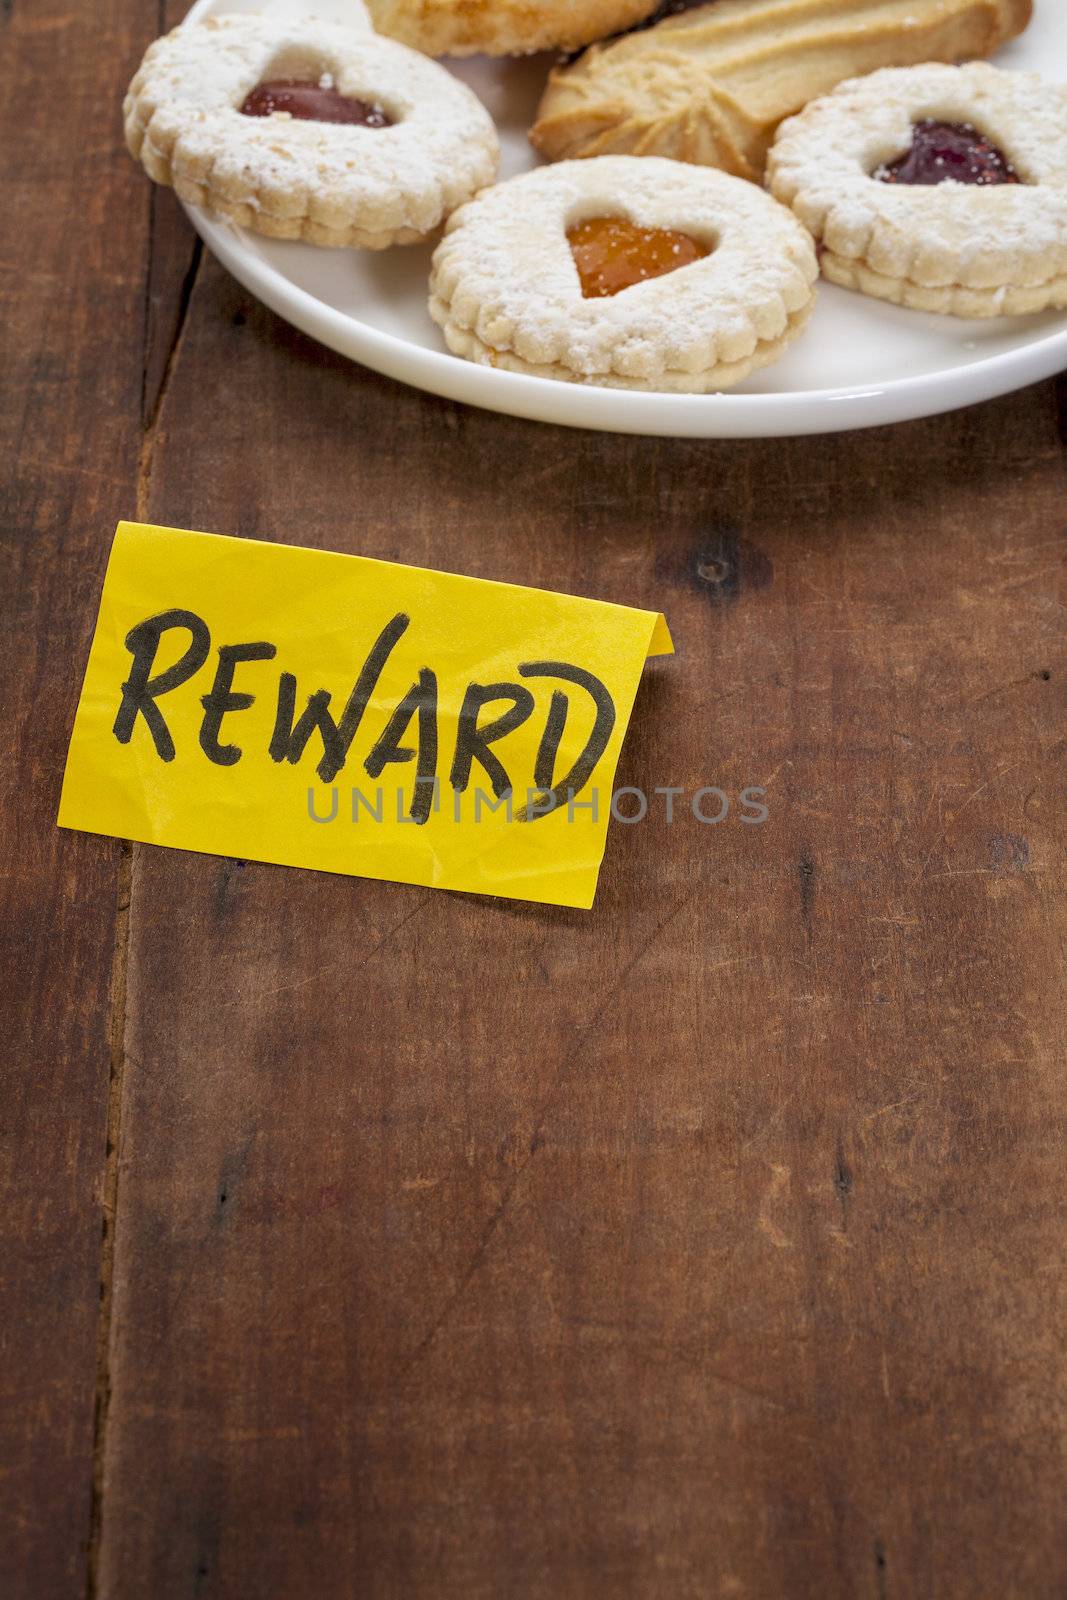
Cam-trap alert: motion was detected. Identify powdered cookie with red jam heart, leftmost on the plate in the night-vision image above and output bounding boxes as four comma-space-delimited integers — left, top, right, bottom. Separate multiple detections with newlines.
123, 8, 499, 250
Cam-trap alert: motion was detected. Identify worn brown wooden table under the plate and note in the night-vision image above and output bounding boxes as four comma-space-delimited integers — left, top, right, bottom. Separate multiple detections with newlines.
0, 0, 1067, 1600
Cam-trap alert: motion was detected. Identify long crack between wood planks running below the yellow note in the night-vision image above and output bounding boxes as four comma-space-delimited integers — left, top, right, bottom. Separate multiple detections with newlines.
85, 845, 134, 1600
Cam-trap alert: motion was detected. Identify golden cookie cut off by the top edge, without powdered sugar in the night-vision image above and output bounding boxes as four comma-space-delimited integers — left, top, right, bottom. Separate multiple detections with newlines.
366, 0, 659, 56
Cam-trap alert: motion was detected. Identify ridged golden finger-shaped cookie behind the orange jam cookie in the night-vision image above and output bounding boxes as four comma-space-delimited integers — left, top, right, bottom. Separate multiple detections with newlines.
530, 0, 1032, 182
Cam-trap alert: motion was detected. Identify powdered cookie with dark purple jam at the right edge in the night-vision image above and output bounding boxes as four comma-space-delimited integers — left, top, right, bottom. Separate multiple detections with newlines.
768, 64, 1067, 317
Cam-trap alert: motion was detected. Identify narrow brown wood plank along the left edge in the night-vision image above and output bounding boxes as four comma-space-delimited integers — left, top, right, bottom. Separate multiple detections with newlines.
0, 0, 167, 1600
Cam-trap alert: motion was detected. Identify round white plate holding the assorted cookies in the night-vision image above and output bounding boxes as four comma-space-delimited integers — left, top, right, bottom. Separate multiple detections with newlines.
179, 0, 1067, 438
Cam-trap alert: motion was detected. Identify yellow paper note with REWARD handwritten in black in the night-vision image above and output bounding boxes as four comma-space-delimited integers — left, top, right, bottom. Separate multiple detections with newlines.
59, 522, 673, 907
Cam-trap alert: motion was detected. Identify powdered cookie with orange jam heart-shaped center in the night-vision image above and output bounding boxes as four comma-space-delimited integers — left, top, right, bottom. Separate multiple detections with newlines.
430, 155, 819, 392
